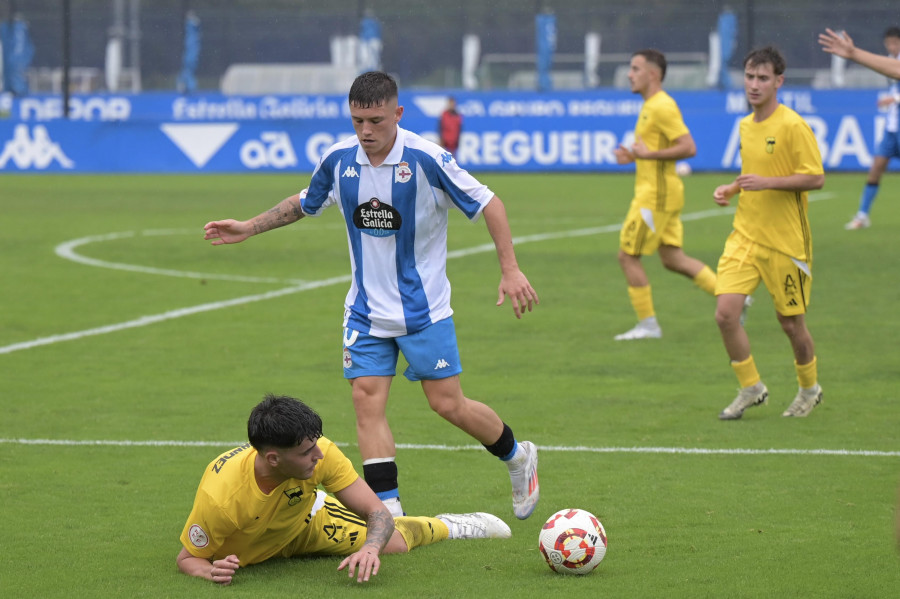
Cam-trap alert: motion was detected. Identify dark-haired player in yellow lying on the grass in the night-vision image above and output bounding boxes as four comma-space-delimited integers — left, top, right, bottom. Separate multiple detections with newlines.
177, 395, 511, 585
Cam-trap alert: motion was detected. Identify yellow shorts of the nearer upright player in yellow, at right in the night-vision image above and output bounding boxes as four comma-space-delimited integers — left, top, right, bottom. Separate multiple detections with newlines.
716, 231, 812, 316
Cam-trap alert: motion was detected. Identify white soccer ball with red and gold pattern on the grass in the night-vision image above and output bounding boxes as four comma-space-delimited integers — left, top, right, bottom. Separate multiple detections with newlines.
538, 509, 606, 574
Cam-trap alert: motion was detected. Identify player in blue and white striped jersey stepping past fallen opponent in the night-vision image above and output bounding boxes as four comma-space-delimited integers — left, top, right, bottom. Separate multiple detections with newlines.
205, 72, 540, 519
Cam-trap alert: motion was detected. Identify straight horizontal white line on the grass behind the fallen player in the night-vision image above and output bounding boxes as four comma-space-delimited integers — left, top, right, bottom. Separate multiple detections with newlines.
0, 438, 900, 458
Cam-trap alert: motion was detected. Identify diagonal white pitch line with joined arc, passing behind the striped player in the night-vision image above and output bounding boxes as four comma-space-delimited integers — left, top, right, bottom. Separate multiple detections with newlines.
0, 192, 834, 354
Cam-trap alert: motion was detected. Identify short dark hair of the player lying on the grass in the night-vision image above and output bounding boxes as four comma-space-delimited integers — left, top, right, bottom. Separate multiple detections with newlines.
247, 393, 322, 451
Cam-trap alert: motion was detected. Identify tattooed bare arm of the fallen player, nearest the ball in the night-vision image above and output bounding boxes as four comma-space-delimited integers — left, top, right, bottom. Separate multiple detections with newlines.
334, 478, 399, 582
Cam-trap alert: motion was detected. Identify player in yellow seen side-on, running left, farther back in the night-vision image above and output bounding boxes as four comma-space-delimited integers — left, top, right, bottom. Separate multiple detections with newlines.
615, 49, 716, 341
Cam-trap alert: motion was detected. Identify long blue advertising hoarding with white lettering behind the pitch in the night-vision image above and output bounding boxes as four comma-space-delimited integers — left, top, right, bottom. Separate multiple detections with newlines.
0, 89, 886, 173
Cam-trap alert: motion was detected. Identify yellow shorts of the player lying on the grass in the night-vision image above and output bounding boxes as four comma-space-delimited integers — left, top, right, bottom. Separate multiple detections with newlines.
282, 495, 367, 557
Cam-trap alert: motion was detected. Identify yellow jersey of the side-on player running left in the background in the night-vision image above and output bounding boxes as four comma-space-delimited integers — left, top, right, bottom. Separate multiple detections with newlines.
634, 90, 690, 212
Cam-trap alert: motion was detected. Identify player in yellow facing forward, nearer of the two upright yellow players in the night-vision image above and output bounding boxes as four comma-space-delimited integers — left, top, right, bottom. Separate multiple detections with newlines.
713, 47, 825, 420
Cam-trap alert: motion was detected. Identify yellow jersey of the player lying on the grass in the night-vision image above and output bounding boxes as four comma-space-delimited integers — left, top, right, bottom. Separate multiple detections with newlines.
181, 437, 359, 565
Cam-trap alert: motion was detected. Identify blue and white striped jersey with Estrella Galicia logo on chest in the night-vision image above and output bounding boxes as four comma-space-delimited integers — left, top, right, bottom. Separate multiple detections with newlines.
301, 127, 494, 337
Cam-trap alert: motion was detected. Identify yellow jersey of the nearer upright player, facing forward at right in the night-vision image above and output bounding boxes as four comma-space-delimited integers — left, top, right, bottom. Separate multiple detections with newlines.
734, 104, 825, 263
